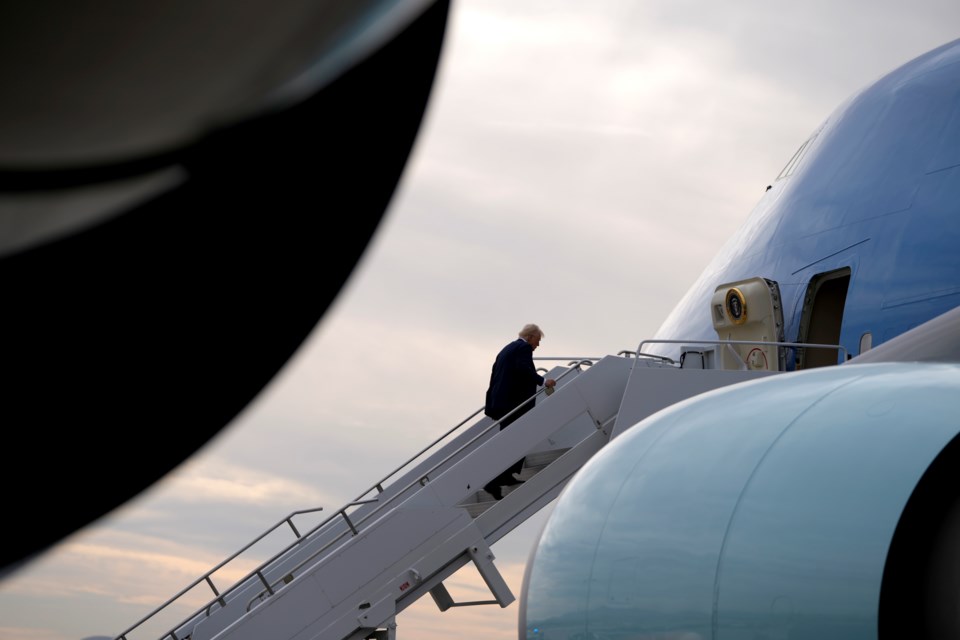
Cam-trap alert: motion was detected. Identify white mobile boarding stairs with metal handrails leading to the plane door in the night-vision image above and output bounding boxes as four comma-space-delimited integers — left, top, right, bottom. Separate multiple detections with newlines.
116, 332, 844, 640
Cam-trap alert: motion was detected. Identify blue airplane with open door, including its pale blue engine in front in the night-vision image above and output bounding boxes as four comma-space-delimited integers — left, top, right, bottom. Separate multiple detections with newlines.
518, 33, 960, 640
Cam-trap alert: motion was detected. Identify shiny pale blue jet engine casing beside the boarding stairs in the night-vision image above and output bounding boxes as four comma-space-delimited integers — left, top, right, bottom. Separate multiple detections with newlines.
520, 362, 960, 640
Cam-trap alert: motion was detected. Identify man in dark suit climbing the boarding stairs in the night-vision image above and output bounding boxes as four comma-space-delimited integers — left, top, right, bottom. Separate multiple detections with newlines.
483, 324, 556, 500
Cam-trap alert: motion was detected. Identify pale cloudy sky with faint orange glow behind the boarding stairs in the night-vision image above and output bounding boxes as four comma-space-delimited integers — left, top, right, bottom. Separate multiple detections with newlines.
0, 0, 960, 640
